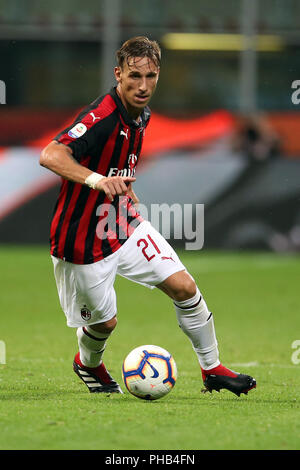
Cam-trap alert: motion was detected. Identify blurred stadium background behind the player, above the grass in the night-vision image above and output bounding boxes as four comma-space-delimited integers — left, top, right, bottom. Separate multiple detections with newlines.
0, 0, 300, 252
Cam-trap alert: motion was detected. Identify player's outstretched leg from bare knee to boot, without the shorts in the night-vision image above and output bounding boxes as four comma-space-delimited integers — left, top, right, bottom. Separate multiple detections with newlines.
157, 271, 256, 396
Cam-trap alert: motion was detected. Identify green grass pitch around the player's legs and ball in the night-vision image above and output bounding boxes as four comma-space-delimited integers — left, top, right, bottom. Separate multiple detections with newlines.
0, 245, 300, 450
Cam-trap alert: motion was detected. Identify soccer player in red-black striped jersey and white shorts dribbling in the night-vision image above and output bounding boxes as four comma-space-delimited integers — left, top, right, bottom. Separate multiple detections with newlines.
40, 36, 256, 395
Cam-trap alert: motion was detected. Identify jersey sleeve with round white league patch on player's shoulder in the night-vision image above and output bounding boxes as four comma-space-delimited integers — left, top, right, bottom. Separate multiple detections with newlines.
54, 111, 101, 162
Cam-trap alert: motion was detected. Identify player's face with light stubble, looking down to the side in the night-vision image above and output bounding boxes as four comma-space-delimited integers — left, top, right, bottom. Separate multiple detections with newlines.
115, 57, 159, 118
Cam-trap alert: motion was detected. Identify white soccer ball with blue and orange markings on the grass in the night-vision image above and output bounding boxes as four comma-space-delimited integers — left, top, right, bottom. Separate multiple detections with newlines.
122, 345, 177, 400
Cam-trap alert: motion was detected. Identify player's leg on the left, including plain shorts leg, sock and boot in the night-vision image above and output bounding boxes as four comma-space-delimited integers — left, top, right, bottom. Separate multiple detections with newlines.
52, 254, 121, 393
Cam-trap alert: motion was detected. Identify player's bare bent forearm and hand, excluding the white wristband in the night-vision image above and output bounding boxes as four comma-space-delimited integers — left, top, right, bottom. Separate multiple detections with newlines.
40, 140, 136, 201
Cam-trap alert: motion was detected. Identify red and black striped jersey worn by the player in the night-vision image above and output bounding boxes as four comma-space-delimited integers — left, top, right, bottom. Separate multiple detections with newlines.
50, 88, 150, 264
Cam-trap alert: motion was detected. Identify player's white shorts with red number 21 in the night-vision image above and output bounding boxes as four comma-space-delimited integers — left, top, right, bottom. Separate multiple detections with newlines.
51, 221, 185, 327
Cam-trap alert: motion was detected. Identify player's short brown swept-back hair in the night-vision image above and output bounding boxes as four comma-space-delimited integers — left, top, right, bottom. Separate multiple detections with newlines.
116, 36, 161, 68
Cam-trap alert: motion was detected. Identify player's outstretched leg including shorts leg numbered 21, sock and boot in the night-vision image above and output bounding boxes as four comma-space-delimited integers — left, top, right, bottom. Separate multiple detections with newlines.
118, 222, 255, 394
